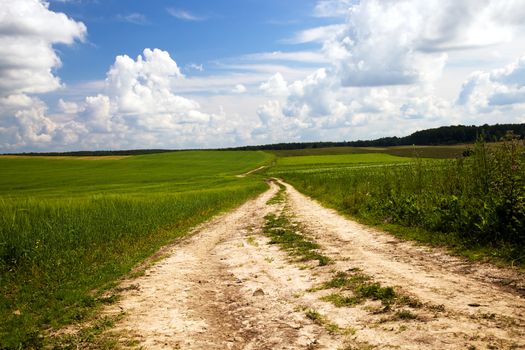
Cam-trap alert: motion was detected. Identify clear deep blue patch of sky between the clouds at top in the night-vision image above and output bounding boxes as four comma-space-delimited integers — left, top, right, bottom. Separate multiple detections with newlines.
50, 0, 328, 83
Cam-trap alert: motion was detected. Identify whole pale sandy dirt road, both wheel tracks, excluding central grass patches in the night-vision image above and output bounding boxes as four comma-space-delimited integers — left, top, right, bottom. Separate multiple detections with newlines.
106, 182, 525, 349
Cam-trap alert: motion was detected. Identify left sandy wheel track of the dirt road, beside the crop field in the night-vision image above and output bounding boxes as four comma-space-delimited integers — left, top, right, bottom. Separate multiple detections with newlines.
108, 184, 337, 349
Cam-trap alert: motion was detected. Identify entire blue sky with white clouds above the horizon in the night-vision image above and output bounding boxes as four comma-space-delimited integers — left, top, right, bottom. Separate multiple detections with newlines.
0, 0, 525, 153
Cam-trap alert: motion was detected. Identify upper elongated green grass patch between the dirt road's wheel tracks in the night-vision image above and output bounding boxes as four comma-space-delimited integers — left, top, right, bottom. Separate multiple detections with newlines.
264, 213, 331, 266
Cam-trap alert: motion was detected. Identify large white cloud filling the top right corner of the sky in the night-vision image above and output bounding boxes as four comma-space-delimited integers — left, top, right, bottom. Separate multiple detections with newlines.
314, 0, 525, 86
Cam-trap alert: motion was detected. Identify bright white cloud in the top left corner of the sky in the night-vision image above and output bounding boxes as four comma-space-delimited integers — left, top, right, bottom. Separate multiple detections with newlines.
0, 0, 86, 96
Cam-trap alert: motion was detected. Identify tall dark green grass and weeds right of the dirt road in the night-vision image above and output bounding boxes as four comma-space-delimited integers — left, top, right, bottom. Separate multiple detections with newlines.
276, 140, 525, 264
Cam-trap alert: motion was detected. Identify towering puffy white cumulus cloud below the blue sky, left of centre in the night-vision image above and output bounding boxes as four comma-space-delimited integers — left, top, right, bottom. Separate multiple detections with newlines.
79, 49, 211, 136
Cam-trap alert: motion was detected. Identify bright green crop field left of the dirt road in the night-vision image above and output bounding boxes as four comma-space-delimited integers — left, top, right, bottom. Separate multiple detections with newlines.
0, 151, 273, 348
